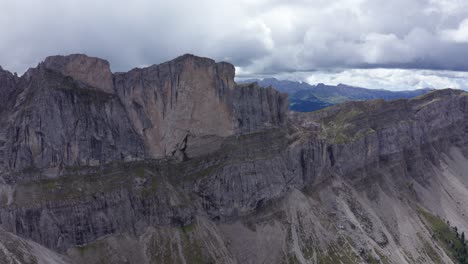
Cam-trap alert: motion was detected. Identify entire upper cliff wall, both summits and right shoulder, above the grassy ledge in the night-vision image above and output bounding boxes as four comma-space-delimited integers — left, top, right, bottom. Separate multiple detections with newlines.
0, 55, 287, 174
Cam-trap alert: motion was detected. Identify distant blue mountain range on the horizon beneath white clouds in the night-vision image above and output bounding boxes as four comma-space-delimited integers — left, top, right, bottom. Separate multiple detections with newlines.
241, 78, 432, 112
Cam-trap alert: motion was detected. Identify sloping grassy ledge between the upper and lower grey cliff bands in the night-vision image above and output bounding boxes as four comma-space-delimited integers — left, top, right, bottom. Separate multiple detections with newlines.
10, 129, 290, 206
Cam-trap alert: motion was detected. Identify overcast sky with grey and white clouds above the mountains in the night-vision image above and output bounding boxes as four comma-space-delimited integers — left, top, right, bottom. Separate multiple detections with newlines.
0, 0, 468, 89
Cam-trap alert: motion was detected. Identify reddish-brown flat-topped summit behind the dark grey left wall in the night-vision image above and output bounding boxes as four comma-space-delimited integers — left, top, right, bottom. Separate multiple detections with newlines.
42, 54, 114, 93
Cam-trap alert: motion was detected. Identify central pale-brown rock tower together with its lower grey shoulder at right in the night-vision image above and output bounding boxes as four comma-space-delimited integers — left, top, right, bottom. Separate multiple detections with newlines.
115, 55, 287, 158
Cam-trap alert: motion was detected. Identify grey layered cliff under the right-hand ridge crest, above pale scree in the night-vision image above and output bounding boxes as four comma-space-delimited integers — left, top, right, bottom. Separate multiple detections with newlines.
293, 89, 468, 182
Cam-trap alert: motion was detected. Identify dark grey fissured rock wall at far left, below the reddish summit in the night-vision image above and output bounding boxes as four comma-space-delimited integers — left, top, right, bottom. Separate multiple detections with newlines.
0, 67, 145, 173
